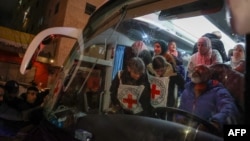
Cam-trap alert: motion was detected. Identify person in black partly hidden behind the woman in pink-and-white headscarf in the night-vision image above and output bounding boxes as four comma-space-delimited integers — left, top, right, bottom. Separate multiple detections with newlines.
193, 31, 228, 62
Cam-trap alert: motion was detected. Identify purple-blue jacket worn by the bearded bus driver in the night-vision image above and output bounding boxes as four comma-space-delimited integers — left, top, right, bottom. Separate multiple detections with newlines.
179, 80, 239, 127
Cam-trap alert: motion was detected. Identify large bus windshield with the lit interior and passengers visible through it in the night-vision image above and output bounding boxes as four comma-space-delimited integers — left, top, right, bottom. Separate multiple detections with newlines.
12, 1, 245, 140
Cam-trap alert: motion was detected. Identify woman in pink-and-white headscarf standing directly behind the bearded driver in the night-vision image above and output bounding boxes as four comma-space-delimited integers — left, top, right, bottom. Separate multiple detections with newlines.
188, 37, 223, 77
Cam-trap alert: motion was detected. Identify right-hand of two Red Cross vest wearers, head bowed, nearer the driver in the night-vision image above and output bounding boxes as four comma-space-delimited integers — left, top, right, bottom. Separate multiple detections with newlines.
149, 55, 185, 120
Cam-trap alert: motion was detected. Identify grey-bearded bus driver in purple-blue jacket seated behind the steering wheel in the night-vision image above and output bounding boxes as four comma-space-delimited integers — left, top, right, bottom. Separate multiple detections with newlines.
176, 65, 240, 131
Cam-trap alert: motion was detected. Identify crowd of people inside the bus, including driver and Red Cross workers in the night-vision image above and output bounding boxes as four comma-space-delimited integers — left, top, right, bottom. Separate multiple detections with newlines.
110, 31, 245, 134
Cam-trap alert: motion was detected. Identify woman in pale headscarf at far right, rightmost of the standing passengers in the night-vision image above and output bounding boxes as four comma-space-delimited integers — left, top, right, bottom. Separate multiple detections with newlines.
226, 44, 246, 74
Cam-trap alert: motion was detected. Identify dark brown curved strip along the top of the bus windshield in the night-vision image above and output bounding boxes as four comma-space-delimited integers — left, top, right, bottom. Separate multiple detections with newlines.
83, 0, 224, 41
